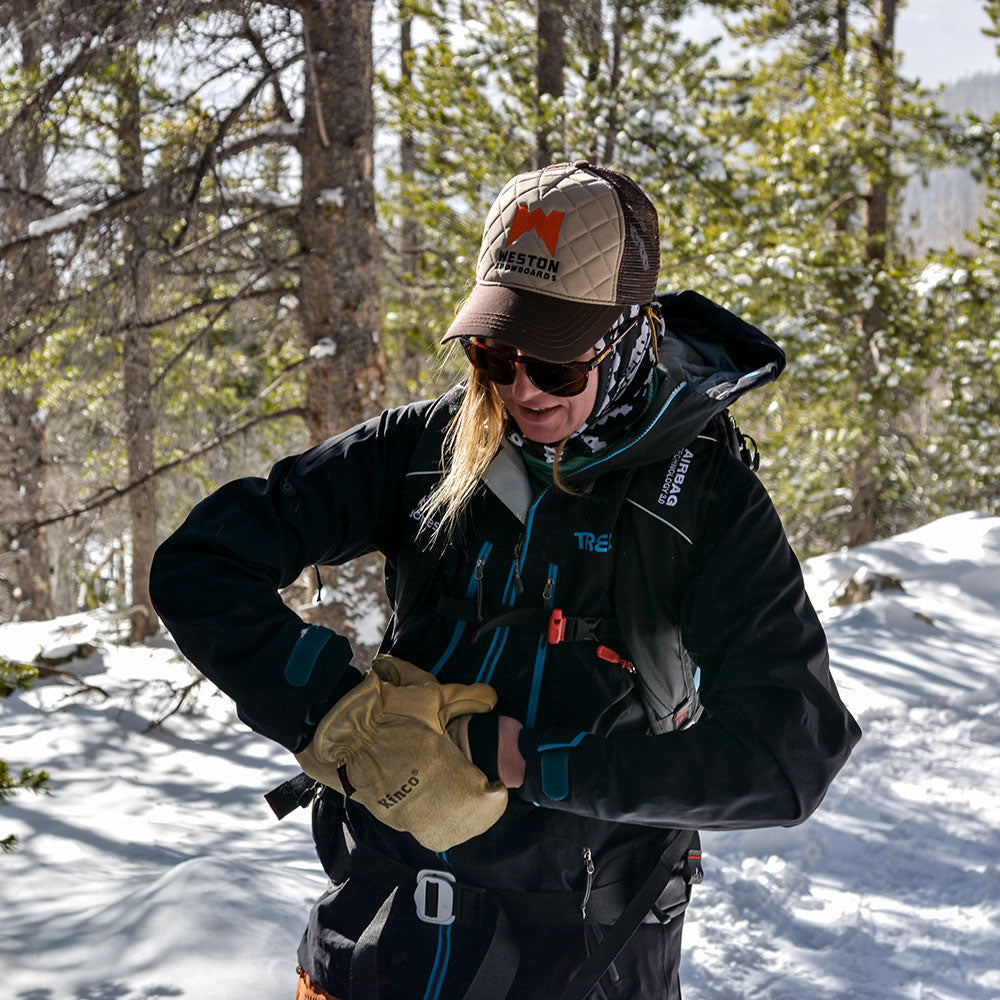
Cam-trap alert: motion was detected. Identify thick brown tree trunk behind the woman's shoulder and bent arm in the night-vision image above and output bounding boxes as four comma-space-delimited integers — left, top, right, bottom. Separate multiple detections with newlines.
299, 0, 387, 663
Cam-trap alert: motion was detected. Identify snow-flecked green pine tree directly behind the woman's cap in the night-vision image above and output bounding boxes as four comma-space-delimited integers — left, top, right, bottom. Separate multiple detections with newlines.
380, 0, 720, 392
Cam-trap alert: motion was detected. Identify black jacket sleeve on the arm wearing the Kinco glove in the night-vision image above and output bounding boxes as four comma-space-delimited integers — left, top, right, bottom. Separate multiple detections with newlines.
150, 404, 428, 750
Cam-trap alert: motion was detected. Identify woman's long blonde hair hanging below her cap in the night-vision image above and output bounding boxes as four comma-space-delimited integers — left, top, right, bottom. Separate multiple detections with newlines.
420, 366, 573, 542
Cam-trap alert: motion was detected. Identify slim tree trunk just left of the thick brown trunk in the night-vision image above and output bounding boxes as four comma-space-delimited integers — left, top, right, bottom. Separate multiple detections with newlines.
117, 52, 159, 643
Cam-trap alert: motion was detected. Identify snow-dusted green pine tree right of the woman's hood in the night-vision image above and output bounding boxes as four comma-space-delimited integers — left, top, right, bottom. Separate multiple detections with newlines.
692, 0, 960, 552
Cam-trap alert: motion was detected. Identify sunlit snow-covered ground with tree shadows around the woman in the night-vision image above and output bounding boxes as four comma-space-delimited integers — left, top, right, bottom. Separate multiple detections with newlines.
0, 514, 1000, 1000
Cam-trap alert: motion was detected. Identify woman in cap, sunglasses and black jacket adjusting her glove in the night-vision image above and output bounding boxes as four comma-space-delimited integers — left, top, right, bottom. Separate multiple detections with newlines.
152, 162, 860, 1000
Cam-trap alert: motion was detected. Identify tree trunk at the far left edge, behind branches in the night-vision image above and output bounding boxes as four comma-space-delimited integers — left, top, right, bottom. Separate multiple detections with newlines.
0, 18, 55, 620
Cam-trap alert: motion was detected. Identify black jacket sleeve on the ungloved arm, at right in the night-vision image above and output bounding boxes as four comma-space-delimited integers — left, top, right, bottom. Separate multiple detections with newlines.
519, 459, 861, 829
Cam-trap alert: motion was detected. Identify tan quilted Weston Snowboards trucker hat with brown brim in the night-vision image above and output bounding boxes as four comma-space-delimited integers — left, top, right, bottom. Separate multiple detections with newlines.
443, 160, 660, 361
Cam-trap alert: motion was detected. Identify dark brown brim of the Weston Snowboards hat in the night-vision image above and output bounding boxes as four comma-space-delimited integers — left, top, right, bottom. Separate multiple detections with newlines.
441, 284, 625, 361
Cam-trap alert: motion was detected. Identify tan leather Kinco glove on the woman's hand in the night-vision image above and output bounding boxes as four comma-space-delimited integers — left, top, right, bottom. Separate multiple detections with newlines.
295, 656, 507, 851
